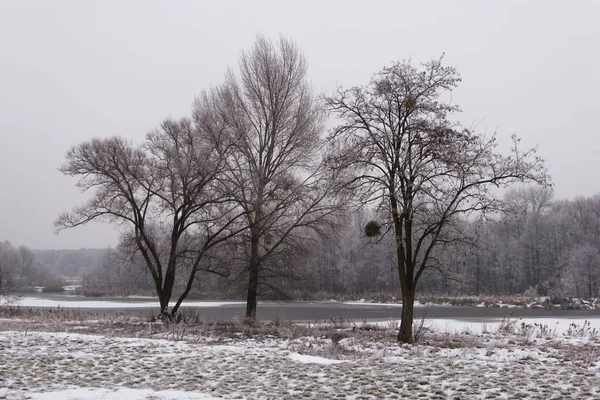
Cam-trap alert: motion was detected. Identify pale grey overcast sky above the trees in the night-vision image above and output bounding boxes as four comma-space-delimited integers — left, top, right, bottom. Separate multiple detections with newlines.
0, 0, 600, 248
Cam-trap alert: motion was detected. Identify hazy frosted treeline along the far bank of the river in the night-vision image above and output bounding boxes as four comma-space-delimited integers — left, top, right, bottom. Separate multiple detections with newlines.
9, 187, 600, 298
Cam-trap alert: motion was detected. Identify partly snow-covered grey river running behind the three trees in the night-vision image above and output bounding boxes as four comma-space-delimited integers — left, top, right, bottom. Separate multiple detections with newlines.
10, 293, 600, 322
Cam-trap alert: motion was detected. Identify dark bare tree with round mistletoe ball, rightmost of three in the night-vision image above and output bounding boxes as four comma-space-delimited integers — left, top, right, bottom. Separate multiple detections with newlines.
326, 59, 546, 343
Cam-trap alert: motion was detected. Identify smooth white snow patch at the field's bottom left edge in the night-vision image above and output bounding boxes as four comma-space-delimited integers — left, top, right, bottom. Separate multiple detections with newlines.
0, 387, 220, 400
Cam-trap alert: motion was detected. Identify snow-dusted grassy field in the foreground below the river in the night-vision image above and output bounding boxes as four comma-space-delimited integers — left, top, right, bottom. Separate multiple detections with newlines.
0, 319, 600, 400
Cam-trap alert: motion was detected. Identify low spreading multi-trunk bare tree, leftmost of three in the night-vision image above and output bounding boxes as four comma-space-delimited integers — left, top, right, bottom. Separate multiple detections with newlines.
55, 118, 241, 317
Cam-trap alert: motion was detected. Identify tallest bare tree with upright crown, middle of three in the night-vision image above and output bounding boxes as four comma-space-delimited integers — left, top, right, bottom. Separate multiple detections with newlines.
194, 37, 341, 320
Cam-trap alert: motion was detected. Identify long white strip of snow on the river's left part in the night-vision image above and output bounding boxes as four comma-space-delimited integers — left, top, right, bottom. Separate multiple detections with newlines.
13, 297, 246, 309
